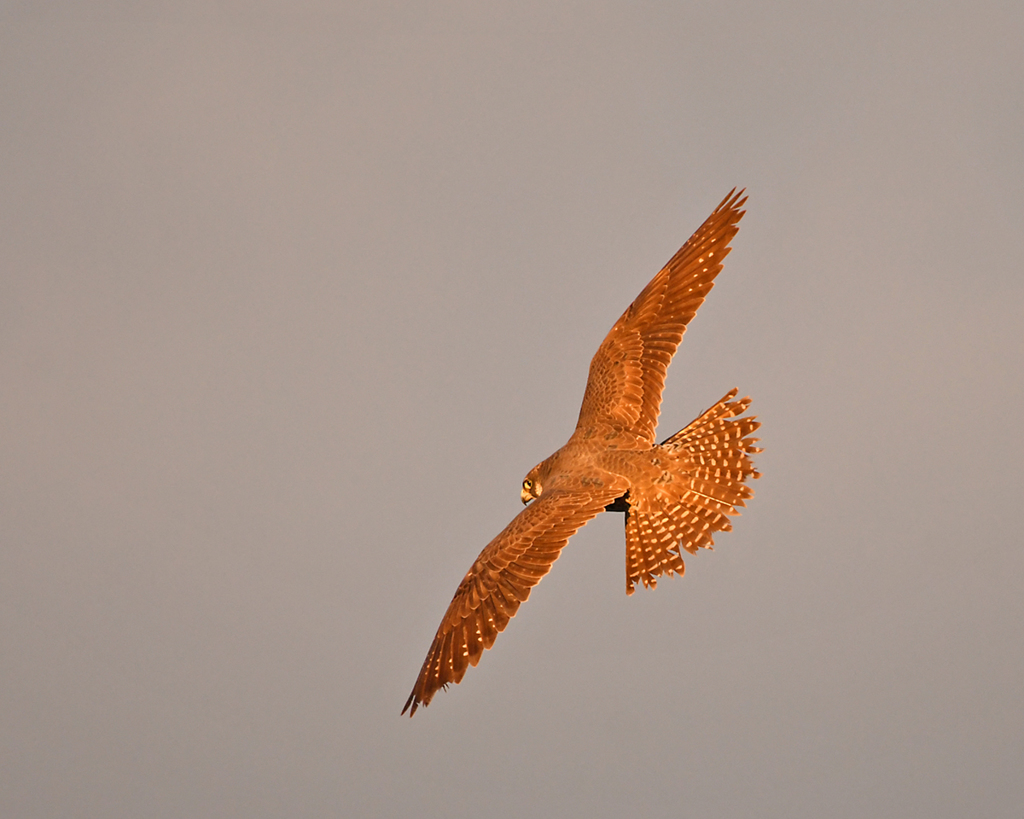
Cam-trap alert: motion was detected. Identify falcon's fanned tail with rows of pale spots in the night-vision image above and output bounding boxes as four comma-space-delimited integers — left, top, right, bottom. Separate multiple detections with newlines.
626, 389, 761, 595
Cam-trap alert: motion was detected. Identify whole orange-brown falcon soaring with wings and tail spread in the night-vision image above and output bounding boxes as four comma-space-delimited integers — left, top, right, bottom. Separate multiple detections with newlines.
401, 189, 761, 717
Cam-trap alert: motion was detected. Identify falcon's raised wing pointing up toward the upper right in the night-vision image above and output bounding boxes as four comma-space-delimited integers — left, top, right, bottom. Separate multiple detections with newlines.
577, 189, 746, 443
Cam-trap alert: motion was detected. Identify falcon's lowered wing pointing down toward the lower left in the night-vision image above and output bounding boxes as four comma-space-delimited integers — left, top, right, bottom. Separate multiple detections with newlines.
401, 489, 621, 717
